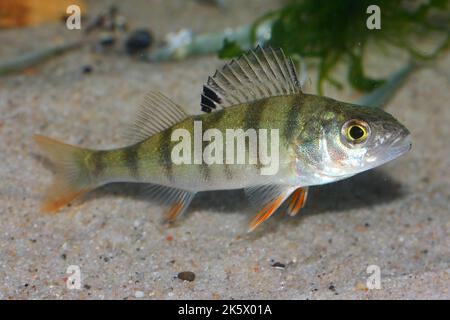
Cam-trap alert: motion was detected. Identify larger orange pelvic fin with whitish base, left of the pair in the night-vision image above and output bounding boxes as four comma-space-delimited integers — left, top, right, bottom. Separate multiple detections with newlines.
245, 185, 295, 232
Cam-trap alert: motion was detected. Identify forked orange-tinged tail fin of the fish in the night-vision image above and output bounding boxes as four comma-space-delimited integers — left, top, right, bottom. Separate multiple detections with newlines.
33, 135, 92, 212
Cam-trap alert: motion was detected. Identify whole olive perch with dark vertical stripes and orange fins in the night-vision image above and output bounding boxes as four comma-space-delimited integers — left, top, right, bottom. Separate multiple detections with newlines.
34, 46, 412, 232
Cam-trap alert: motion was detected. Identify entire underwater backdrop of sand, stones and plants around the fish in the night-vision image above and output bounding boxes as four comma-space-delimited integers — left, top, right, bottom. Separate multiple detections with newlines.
0, 0, 450, 299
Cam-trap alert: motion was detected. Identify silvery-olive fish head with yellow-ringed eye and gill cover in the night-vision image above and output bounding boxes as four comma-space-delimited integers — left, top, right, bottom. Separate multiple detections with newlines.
297, 100, 411, 184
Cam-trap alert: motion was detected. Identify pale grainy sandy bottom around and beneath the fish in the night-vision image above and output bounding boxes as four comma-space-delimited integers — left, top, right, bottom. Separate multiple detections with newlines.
0, 1, 450, 299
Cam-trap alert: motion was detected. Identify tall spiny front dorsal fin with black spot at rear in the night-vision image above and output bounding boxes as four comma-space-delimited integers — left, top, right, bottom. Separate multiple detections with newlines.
201, 46, 301, 112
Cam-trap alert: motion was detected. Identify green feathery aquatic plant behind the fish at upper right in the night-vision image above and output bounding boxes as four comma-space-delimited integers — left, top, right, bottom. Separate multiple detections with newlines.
219, 0, 450, 93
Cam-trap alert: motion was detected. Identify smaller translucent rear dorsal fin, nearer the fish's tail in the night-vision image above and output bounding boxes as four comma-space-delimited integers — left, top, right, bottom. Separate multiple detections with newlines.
127, 92, 188, 143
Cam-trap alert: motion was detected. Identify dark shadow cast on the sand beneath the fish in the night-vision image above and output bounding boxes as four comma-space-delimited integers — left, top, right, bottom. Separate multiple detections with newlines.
85, 170, 407, 222
